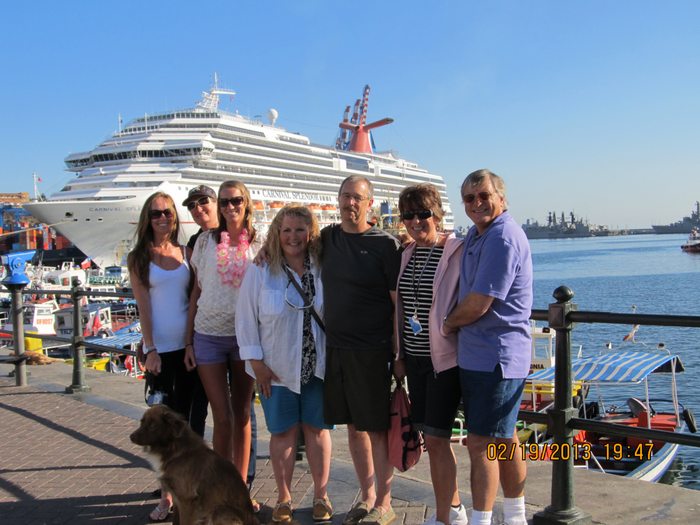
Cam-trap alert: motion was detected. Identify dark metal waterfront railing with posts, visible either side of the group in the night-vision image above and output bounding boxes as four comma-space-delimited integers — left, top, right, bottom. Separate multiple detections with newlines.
5, 286, 700, 525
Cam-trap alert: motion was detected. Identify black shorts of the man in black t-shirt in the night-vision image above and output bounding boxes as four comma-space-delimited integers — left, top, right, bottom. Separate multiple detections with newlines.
323, 347, 393, 432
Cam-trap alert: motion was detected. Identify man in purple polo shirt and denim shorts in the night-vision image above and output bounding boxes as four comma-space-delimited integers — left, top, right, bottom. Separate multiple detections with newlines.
444, 170, 532, 525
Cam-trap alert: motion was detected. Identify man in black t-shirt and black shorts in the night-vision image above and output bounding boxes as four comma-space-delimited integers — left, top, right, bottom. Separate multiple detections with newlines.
321, 176, 401, 525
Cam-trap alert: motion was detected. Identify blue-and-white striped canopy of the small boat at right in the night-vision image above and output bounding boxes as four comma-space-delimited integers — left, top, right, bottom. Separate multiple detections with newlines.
528, 352, 685, 383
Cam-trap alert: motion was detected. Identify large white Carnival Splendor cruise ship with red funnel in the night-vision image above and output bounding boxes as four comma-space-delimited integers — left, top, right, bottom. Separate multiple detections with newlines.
24, 78, 454, 267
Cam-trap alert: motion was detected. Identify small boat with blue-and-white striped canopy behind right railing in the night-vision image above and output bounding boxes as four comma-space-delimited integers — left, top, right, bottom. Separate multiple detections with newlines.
529, 350, 697, 482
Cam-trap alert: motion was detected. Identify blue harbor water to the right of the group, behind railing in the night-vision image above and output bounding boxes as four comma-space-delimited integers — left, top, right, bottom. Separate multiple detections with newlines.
530, 235, 700, 490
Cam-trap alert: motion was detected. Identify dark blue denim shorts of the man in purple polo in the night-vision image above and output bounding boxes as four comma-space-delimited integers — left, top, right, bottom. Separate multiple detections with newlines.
459, 365, 525, 439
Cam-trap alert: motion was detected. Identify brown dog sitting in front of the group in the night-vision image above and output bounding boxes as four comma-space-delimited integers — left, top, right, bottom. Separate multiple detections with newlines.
130, 405, 258, 525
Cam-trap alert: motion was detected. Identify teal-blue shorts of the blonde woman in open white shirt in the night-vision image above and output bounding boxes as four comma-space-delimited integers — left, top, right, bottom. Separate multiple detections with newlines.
260, 377, 333, 434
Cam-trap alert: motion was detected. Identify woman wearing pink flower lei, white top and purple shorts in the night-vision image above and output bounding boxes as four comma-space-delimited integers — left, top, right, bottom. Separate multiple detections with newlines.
185, 180, 259, 488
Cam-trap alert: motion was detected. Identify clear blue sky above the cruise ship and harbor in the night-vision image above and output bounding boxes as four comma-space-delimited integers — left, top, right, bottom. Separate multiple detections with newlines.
0, 0, 700, 228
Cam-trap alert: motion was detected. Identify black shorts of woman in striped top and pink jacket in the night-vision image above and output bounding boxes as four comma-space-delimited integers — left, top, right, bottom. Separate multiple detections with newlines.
405, 355, 462, 438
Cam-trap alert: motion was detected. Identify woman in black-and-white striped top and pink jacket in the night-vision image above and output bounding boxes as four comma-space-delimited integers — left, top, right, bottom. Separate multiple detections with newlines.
395, 183, 467, 525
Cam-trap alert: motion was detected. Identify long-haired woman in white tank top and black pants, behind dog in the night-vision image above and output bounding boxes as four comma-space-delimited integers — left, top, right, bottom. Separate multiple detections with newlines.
127, 192, 192, 521
